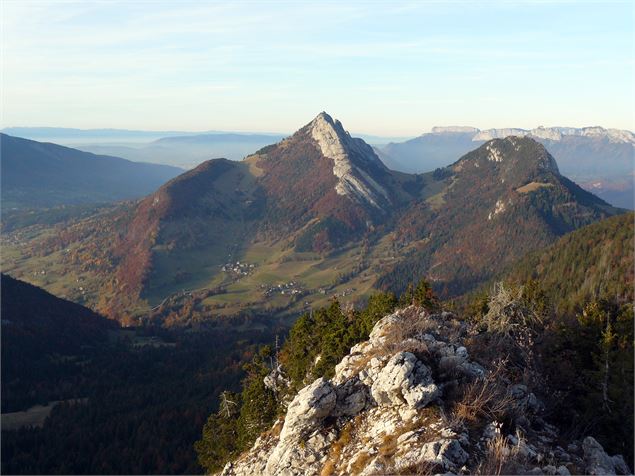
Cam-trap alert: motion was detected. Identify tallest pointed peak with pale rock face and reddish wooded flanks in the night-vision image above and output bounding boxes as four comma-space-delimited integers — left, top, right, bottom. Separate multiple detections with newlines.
243, 112, 412, 242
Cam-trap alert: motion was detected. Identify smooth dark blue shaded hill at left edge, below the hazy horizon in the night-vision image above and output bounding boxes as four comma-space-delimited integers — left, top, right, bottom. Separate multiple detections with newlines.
0, 134, 183, 210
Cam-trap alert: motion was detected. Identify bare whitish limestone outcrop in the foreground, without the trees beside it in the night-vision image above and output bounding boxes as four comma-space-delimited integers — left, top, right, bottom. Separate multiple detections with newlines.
222, 307, 630, 476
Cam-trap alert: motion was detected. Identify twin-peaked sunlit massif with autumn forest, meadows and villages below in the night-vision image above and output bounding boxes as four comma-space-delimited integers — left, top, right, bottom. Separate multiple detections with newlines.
1, 113, 620, 322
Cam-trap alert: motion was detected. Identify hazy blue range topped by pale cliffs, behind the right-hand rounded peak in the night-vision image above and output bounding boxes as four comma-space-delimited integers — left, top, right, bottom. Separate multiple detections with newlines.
379, 126, 635, 209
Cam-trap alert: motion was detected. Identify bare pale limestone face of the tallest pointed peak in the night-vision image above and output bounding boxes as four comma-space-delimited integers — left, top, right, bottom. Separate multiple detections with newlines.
308, 112, 391, 209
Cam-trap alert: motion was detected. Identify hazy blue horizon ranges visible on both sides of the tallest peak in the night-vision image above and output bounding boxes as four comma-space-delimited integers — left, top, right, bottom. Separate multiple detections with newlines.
4, 126, 635, 209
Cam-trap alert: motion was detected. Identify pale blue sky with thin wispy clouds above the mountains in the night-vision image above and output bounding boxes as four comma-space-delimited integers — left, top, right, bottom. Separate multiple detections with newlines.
0, 0, 635, 136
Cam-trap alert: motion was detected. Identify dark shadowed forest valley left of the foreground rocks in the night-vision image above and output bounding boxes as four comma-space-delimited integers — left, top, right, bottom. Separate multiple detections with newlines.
2, 274, 286, 474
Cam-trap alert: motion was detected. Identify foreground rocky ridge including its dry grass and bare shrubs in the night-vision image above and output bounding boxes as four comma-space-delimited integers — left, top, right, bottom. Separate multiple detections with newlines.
217, 304, 630, 476
